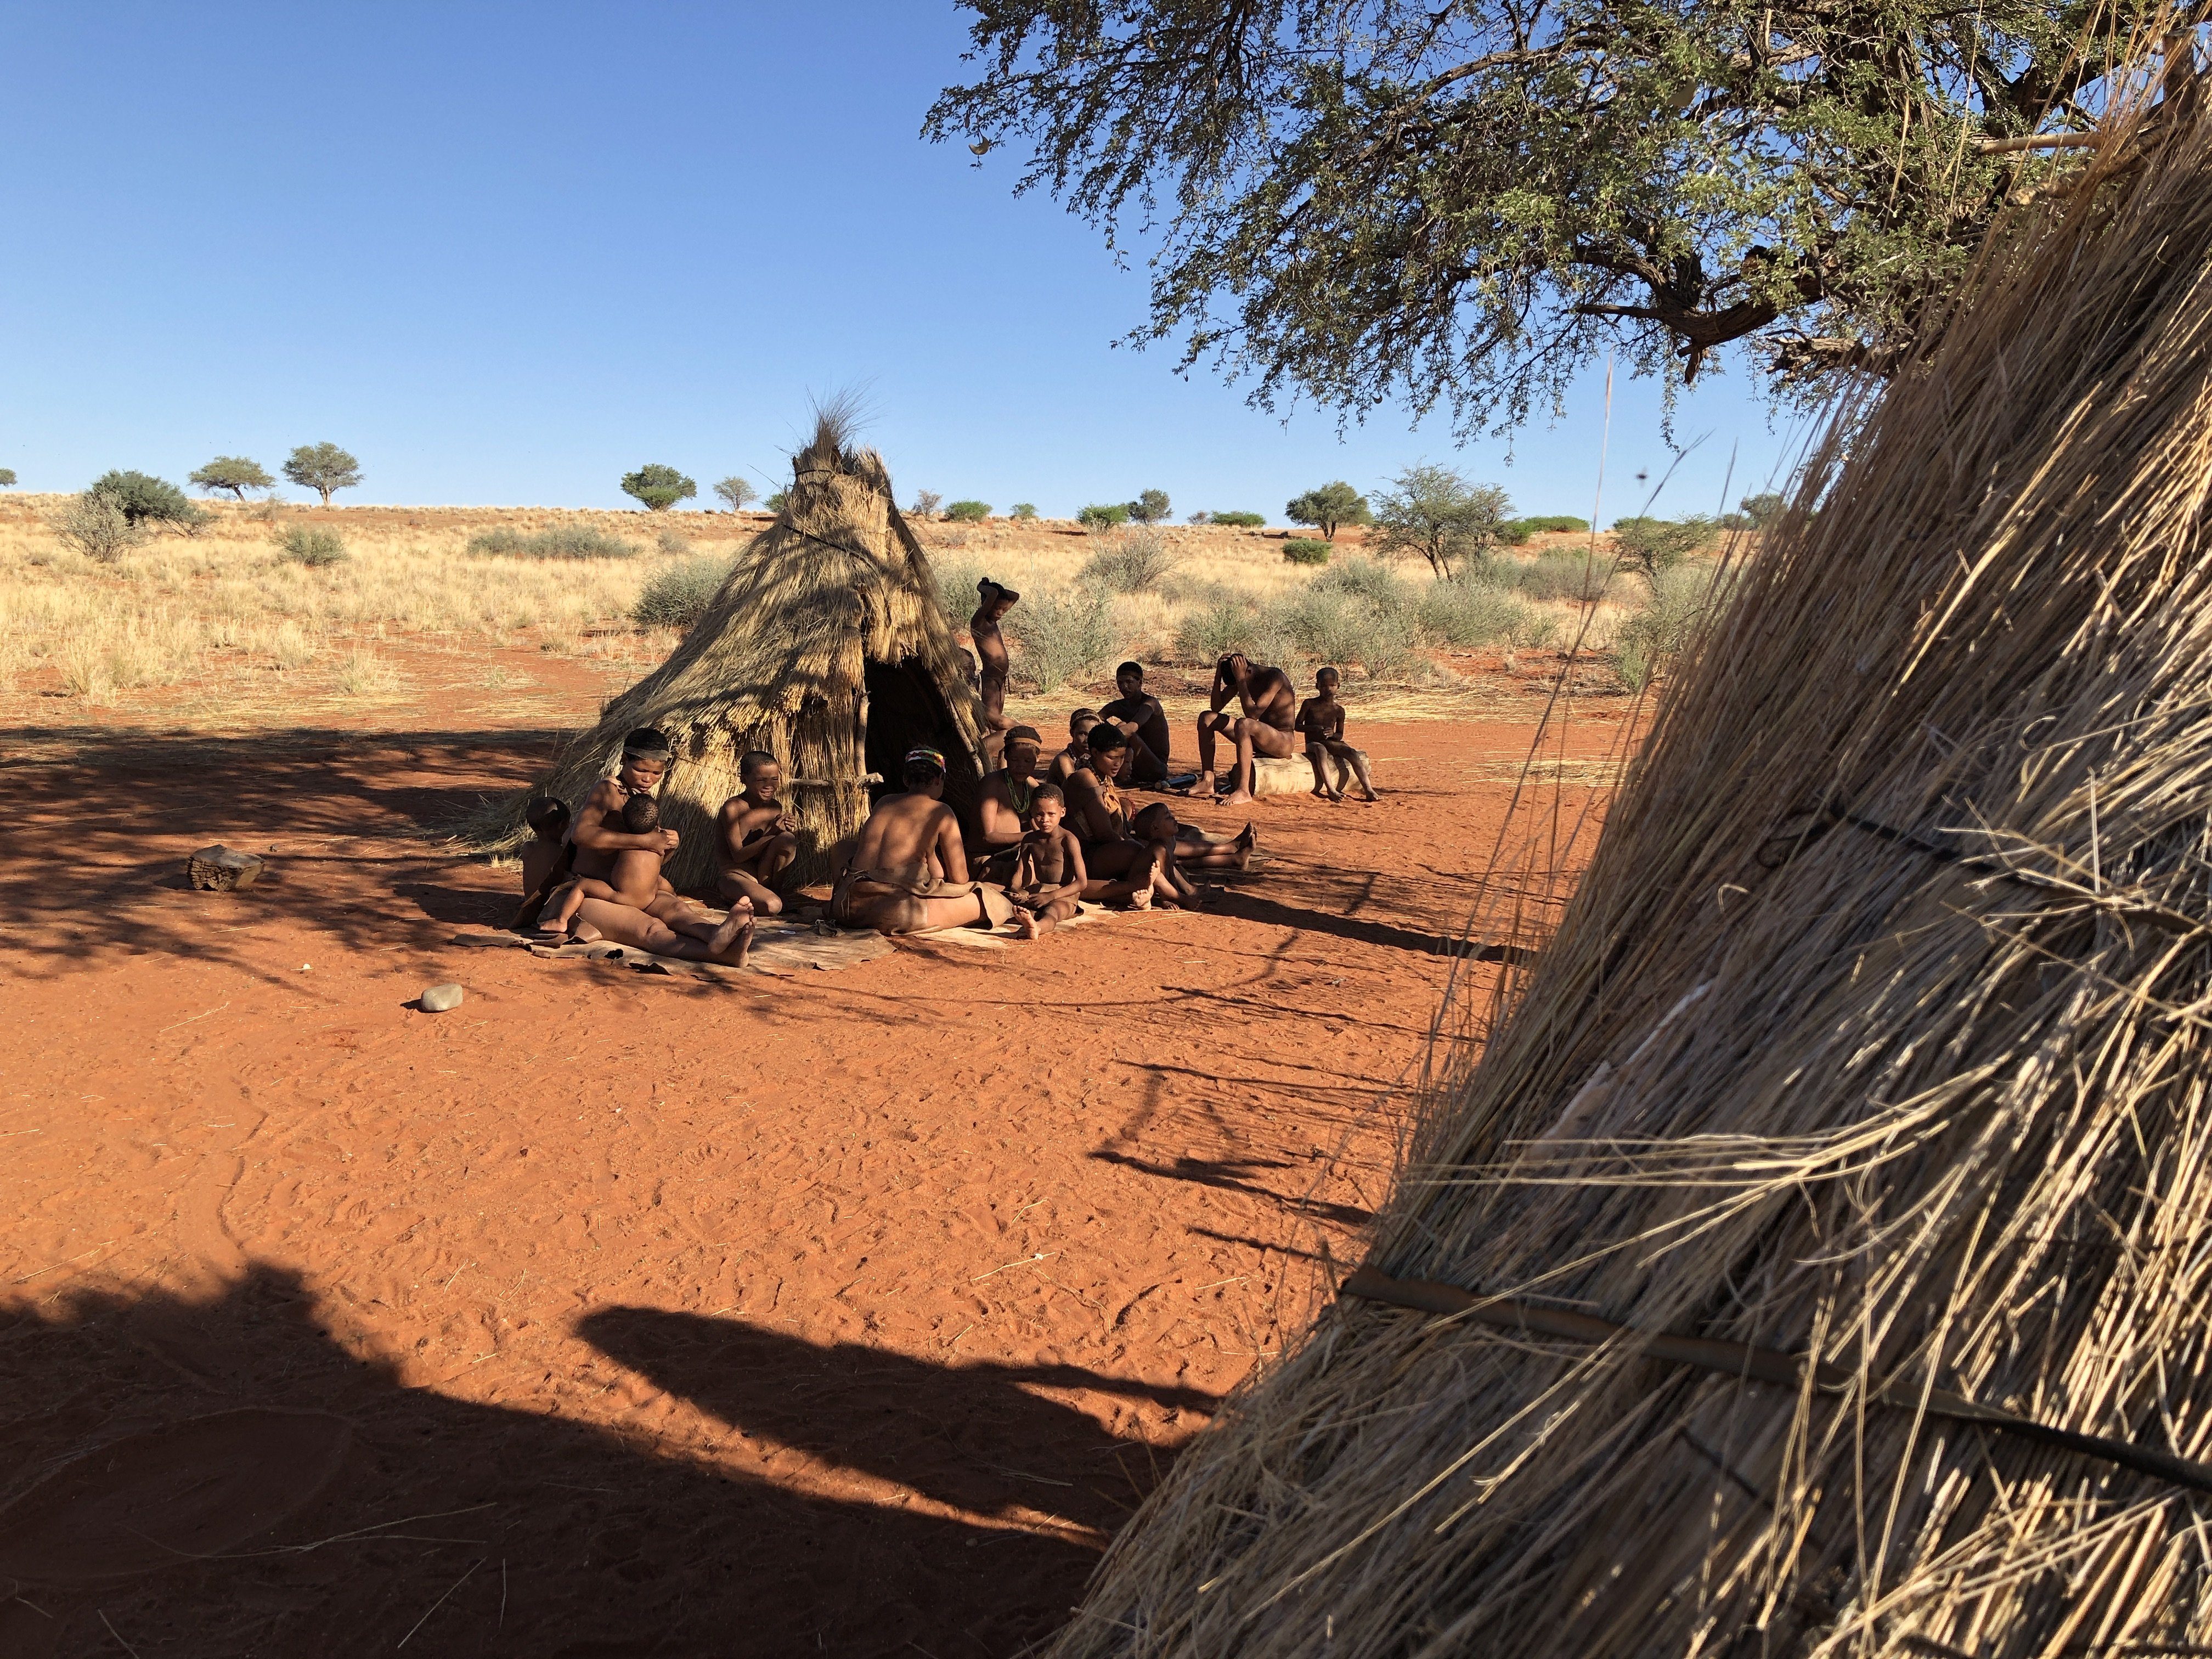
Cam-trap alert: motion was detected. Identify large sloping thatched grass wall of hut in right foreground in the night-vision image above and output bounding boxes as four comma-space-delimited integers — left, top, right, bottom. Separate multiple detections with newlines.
1055, 88, 2212, 1659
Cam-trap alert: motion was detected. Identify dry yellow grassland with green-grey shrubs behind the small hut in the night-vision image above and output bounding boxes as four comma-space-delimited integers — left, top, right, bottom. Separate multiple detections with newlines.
0, 495, 1681, 725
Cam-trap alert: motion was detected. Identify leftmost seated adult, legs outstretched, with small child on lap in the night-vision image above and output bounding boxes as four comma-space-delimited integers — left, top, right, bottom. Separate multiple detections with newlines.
546, 725, 752, 967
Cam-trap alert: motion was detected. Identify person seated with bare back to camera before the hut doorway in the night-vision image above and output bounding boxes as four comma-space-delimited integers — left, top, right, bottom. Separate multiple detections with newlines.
830, 750, 1013, 934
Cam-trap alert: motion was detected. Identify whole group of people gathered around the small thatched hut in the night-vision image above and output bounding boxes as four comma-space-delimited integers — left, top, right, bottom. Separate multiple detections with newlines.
513, 614, 1376, 964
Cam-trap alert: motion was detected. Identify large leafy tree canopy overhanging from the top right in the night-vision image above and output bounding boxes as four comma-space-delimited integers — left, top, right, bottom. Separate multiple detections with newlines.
922, 0, 2176, 431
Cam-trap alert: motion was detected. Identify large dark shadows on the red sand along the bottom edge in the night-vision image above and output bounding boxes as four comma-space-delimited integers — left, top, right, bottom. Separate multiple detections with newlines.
0, 1265, 1197, 1659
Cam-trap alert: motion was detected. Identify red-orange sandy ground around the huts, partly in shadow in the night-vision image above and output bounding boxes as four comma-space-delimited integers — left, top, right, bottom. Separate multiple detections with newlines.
0, 654, 1617, 1659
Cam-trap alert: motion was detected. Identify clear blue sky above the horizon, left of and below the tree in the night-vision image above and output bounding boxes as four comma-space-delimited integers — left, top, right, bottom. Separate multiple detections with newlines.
0, 0, 1790, 520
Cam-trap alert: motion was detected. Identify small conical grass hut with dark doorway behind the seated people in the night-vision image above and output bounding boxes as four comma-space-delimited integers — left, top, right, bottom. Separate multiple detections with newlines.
515, 407, 982, 887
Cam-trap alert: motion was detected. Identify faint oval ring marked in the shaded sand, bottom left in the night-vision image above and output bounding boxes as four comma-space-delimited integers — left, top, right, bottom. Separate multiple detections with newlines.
0, 1409, 352, 1586
